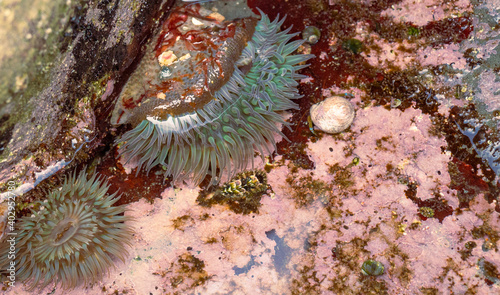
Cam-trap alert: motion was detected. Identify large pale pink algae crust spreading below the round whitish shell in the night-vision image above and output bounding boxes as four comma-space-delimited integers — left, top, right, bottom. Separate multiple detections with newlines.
5, 101, 499, 294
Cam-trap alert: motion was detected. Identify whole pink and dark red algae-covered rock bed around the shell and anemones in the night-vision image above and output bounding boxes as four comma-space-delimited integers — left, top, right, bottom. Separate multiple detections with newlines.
0, 0, 500, 295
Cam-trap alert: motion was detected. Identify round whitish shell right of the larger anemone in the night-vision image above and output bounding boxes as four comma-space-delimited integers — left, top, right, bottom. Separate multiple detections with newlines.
311, 96, 355, 133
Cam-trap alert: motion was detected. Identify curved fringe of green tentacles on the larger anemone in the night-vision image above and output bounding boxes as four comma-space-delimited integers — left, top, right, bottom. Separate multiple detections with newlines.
119, 13, 312, 185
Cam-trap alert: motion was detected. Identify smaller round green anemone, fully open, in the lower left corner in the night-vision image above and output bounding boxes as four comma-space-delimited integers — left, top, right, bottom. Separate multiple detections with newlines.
0, 172, 132, 289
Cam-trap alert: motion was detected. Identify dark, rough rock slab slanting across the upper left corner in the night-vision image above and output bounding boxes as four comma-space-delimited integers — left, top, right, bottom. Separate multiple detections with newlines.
0, 0, 174, 199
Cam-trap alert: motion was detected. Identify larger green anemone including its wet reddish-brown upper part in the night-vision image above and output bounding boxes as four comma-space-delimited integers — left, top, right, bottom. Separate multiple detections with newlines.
112, 5, 312, 185
